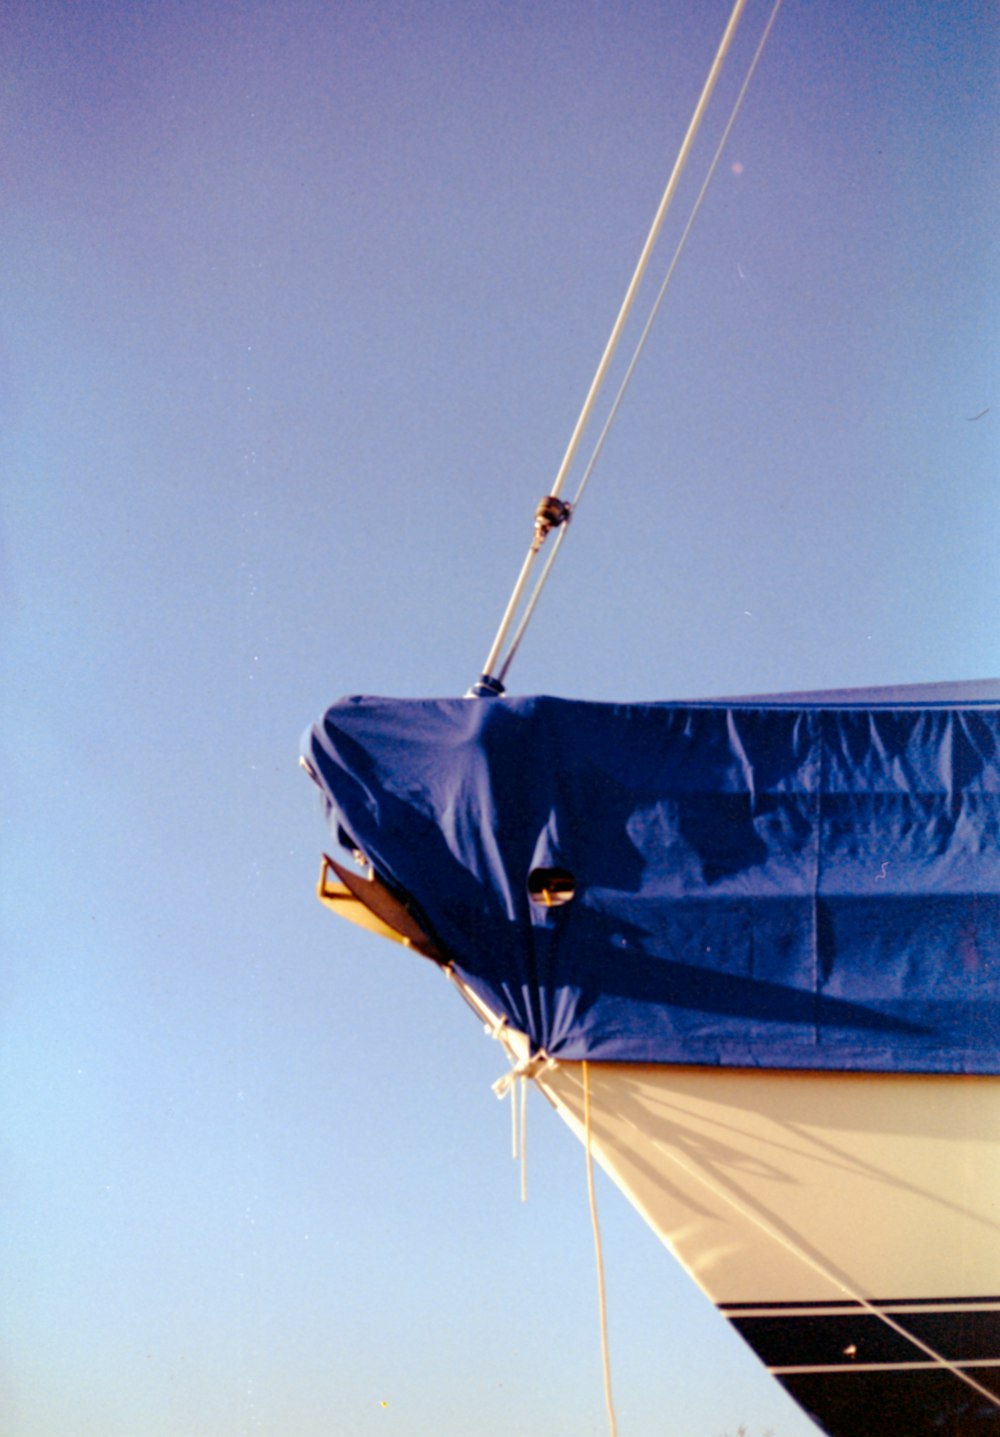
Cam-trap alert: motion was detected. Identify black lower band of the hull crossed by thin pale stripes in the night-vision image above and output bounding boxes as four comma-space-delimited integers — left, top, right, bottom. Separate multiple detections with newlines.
723, 1298, 1000, 1437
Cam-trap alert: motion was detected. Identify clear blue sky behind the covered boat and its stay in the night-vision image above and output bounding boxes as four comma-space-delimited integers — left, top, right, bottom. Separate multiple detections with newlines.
0, 0, 1000, 1437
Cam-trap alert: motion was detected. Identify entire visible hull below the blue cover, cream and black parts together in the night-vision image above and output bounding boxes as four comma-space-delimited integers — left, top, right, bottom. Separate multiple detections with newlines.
479, 1005, 1000, 1437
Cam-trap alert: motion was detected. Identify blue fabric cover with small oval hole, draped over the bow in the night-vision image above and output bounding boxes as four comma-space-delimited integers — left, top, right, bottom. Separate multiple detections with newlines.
303, 684, 1000, 1072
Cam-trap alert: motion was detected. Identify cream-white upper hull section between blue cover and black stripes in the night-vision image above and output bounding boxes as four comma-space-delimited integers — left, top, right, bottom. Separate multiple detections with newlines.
537, 1063, 1000, 1310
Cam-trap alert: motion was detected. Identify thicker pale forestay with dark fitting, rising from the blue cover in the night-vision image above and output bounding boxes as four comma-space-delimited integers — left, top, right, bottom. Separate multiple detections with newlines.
471, 0, 746, 694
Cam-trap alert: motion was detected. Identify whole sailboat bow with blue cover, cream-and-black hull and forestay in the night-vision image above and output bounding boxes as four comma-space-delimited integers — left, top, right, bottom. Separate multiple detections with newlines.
302, 4, 1000, 1437
